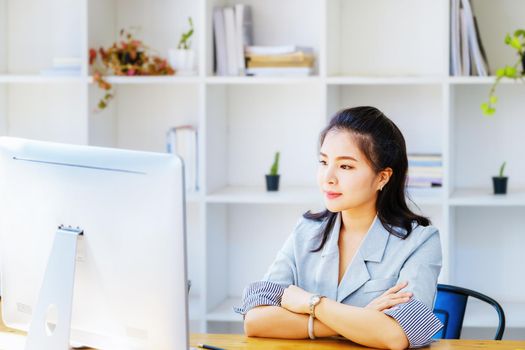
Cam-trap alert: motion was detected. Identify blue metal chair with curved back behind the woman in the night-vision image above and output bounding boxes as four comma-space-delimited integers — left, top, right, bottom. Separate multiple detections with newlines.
432, 284, 505, 340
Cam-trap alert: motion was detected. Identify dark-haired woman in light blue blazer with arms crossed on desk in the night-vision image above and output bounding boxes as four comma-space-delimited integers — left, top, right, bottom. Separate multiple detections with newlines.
236, 107, 442, 349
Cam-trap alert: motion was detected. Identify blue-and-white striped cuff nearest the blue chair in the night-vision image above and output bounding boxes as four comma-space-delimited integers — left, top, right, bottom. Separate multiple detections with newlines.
383, 298, 443, 348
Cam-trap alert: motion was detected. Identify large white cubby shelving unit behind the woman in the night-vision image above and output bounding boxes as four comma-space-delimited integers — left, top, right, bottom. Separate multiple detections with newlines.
0, 0, 525, 340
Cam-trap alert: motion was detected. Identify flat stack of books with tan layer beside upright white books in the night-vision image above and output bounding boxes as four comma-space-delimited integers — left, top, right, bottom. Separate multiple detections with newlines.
245, 45, 314, 76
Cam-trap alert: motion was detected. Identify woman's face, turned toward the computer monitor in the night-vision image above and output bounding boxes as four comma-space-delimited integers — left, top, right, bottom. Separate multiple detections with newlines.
317, 130, 382, 212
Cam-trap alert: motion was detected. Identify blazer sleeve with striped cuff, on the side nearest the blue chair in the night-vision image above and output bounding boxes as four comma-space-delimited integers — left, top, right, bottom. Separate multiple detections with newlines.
384, 226, 443, 348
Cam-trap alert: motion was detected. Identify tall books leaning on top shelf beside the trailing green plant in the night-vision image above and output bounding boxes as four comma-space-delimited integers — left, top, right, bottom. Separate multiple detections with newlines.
450, 0, 490, 76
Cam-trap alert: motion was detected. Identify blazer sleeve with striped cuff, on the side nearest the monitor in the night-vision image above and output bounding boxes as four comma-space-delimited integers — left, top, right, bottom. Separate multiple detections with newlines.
233, 219, 302, 316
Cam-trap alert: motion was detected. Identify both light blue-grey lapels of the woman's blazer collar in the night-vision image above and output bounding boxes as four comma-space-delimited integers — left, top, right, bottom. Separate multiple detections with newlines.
318, 213, 390, 302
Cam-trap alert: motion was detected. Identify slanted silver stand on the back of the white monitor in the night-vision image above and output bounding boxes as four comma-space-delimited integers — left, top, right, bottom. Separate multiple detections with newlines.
25, 225, 83, 350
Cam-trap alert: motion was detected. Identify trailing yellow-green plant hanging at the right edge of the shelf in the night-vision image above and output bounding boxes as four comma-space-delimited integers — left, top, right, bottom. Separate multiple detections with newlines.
481, 29, 525, 116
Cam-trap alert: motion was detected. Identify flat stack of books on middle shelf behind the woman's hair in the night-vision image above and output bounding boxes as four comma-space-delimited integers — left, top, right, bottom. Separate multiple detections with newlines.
407, 154, 443, 188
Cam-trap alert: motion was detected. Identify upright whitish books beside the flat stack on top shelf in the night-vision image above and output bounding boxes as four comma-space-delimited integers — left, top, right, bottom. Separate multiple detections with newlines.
213, 4, 253, 76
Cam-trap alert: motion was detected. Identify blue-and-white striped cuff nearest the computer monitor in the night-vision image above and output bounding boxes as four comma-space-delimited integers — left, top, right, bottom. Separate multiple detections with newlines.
233, 281, 286, 316
